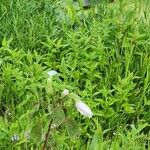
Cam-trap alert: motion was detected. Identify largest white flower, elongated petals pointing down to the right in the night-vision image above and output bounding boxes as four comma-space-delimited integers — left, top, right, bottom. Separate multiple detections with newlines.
75, 101, 93, 118
